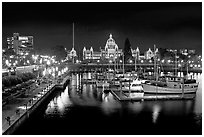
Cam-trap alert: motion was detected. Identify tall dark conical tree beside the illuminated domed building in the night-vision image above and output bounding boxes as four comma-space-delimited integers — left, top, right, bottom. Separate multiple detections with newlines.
124, 38, 132, 62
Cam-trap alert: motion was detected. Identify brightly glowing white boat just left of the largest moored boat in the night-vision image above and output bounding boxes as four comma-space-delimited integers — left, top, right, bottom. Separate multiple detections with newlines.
122, 79, 144, 98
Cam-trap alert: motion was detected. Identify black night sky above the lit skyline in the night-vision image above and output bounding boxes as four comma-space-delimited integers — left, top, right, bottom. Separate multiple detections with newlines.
2, 2, 202, 53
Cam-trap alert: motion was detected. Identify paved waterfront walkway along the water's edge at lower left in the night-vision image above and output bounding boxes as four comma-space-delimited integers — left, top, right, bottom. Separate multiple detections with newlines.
2, 80, 55, 133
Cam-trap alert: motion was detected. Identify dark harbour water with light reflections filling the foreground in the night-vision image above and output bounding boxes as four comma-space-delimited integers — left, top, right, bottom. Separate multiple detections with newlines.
14, 73, 202, 135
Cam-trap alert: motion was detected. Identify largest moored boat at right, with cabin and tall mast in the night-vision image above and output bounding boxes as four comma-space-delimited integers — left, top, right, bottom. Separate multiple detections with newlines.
143, 45, 199, 94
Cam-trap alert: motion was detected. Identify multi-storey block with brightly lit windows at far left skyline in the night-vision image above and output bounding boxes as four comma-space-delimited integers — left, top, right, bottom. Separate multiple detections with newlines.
7, 33, 33, 55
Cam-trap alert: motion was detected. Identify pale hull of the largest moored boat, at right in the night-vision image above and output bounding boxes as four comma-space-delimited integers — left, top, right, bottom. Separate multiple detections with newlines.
143, 84, 197, 94
